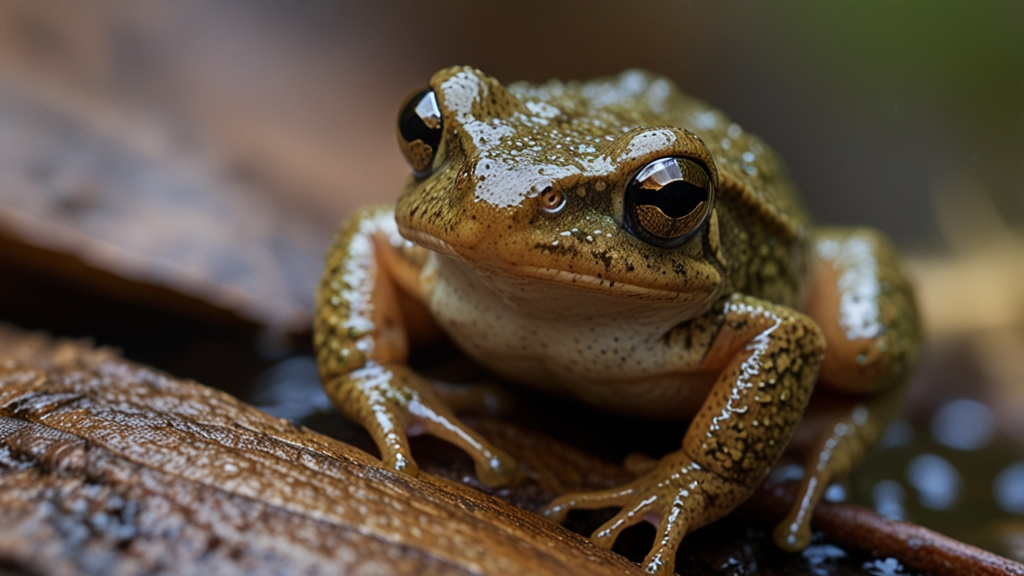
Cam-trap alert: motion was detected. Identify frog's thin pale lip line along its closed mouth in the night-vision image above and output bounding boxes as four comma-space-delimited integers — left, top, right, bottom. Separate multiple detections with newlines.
399, 227, 708, 302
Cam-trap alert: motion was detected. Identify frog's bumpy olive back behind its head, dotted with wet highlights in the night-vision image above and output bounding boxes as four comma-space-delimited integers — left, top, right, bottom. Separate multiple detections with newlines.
509, 70, 810, 306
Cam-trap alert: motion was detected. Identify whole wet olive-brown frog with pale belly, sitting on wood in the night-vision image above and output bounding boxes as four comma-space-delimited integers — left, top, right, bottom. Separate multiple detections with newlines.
313, 66, 921, 574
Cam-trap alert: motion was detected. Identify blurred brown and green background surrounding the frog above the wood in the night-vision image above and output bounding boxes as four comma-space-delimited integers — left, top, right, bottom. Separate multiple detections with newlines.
0, 0, 1024, 560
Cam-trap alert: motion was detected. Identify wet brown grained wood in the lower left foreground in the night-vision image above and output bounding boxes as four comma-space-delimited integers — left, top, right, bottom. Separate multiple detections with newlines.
0, 328, 639, 574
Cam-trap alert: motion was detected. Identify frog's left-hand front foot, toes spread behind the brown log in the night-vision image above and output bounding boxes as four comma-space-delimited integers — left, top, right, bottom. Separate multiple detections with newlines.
325, 363, 518, 487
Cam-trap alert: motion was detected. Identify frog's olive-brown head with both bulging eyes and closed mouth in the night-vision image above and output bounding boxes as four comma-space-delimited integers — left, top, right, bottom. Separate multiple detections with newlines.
395, 67, 726, 303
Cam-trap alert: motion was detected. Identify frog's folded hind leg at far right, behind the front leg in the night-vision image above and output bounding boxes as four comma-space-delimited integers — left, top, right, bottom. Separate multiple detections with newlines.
774, 229, 921, 550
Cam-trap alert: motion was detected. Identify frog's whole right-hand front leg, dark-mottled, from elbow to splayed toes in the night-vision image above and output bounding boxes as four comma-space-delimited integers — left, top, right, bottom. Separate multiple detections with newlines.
545, 295, 824, 574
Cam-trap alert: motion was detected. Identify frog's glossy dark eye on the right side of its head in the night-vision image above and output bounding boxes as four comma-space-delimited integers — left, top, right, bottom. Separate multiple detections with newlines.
624, 157, 715, 248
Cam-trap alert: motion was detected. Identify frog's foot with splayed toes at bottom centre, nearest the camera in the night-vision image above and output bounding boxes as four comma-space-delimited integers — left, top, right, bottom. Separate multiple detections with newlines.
543, 451, 751, 575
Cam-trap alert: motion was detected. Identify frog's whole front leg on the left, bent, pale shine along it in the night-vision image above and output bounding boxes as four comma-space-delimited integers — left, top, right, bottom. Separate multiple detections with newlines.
313, 208, 517, 486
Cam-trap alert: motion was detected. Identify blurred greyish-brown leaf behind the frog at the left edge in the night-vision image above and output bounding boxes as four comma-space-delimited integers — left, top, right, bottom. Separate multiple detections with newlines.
0, 77, 336, 334
